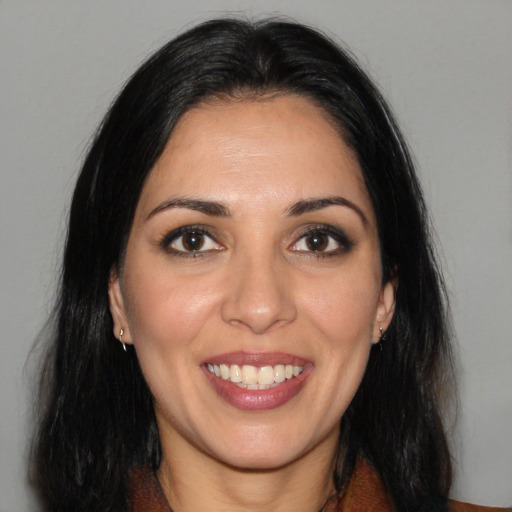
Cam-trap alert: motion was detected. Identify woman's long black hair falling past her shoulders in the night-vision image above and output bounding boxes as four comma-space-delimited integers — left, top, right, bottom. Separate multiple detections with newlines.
35, 20, 451, 512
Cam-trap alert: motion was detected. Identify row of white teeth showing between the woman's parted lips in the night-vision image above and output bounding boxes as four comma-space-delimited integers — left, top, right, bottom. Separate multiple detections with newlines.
207, 364, 304, 389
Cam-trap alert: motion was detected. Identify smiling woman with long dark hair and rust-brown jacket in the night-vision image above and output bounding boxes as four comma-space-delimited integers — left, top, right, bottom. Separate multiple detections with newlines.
33, 20, 508, 512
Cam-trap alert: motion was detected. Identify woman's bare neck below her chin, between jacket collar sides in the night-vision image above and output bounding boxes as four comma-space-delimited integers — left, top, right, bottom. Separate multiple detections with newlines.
158, 431, 338, 512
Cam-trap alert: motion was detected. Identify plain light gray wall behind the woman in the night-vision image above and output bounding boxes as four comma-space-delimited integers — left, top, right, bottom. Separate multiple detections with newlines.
0, 0, 512, 512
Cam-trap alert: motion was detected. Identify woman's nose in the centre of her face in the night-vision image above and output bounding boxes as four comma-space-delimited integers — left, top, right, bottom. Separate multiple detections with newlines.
221, 250, 297, 334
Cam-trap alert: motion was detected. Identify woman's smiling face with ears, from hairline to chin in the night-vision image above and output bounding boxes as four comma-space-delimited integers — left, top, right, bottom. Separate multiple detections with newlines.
110, 96, 394, 468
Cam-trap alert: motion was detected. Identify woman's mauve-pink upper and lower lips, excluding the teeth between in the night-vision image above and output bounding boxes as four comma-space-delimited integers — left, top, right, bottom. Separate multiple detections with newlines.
201, 352, 314, 411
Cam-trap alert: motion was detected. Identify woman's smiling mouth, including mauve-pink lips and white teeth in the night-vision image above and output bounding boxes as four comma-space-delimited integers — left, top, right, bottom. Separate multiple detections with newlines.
202, 352, 313, 411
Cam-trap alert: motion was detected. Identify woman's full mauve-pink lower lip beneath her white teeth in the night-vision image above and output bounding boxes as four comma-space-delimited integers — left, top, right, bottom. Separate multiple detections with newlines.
203, 364, 313, 411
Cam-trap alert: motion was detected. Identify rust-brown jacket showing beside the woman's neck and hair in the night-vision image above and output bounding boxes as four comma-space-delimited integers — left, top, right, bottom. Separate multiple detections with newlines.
129, 460, 512, 512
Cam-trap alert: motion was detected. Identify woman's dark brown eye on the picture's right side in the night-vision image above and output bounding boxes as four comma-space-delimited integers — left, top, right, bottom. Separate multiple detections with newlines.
290, 226, 353, 256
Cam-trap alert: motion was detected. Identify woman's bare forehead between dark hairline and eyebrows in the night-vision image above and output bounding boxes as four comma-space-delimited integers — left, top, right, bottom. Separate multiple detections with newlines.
139, 95, 372, 216
